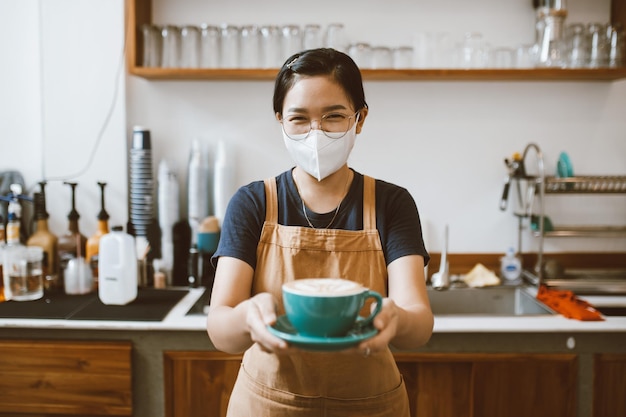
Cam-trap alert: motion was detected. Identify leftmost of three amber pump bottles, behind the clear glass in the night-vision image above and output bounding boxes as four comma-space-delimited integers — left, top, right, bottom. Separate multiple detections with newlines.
26, 182, 59, 290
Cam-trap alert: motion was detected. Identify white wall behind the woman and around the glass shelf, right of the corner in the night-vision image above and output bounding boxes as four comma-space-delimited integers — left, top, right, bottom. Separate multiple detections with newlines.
127, 0, 626, 252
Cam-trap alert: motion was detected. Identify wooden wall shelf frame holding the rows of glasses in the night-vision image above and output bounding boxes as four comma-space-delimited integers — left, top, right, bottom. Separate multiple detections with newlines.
126, 0, 626, 81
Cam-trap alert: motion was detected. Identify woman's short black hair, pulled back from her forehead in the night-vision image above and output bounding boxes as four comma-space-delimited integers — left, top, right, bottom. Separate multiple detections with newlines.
273, 48, 367, 114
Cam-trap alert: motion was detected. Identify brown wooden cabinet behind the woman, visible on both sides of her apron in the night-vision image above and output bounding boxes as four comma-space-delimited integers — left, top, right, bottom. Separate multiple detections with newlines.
164, 351, 577, 417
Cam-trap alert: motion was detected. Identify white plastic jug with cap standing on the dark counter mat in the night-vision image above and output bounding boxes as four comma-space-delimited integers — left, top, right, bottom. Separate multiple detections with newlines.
98, 226, 137, 305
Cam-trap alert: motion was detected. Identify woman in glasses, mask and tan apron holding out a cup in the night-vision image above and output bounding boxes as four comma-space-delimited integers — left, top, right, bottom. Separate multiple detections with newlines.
207, 49, 433, 417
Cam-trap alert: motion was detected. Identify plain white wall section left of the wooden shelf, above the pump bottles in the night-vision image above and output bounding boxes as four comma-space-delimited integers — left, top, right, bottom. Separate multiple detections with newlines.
0, 0, 127, 236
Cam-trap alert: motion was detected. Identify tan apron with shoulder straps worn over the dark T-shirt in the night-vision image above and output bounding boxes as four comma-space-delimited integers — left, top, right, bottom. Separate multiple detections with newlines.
227, 177, 409, 417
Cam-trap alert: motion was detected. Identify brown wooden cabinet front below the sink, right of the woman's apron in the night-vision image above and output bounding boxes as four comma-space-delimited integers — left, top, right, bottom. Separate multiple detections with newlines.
396, 353, 577, 417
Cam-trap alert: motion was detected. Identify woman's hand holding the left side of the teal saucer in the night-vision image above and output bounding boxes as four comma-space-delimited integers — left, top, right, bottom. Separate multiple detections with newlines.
246, 292, 292, 354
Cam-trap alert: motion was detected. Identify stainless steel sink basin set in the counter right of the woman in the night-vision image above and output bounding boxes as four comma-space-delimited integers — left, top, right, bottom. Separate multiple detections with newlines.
428, 287, 555, 316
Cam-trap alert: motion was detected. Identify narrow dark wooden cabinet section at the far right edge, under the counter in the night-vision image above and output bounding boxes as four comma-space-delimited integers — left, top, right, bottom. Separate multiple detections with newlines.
593, 353, 626, 417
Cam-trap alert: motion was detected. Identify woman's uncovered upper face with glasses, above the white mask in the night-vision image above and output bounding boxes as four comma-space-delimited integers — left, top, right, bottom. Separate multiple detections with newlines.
276, 76, 367, 133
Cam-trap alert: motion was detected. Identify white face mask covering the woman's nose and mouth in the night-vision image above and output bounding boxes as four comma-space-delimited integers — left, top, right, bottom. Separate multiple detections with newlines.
283, 119, 358, 181
